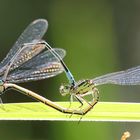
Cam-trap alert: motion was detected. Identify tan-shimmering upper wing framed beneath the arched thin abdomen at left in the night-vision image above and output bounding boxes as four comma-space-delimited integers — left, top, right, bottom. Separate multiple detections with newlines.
0, 43, 46, 81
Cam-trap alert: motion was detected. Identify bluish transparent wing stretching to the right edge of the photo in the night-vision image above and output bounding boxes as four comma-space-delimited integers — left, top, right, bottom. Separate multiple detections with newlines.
92, 66, 140, 85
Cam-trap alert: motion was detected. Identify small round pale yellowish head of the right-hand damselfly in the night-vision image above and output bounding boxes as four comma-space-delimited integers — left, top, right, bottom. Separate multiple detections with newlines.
59, 85, 71, 96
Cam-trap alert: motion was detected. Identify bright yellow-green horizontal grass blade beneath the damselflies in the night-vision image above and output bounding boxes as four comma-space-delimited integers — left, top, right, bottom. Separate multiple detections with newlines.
0, 102, 140, 122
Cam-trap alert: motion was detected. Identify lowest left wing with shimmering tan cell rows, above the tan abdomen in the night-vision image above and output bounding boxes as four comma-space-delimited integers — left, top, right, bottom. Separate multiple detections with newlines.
7, 62, 64, 83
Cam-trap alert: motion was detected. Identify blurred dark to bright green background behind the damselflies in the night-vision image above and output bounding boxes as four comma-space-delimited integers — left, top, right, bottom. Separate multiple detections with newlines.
0, 0, 140, 140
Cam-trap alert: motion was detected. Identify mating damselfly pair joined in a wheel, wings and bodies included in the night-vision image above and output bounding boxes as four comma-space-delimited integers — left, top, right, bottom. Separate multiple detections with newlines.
0, 19, 140, 115
